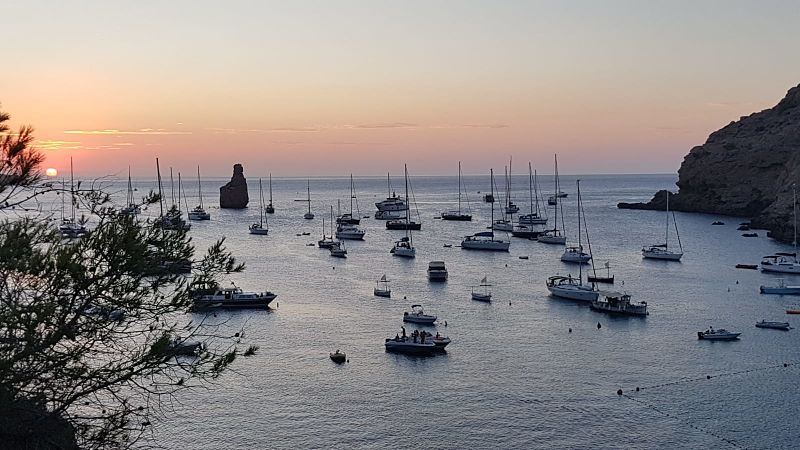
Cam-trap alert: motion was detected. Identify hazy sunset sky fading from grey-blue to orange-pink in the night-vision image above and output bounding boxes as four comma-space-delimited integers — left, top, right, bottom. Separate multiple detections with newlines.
0, 0, 800, 176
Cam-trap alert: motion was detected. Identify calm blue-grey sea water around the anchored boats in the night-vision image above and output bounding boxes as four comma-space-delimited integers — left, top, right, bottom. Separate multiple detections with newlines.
59, 168, 800, 449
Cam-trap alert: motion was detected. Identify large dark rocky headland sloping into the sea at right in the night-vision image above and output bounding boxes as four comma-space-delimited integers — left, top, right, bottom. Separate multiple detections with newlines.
617, 85, 800, 242
